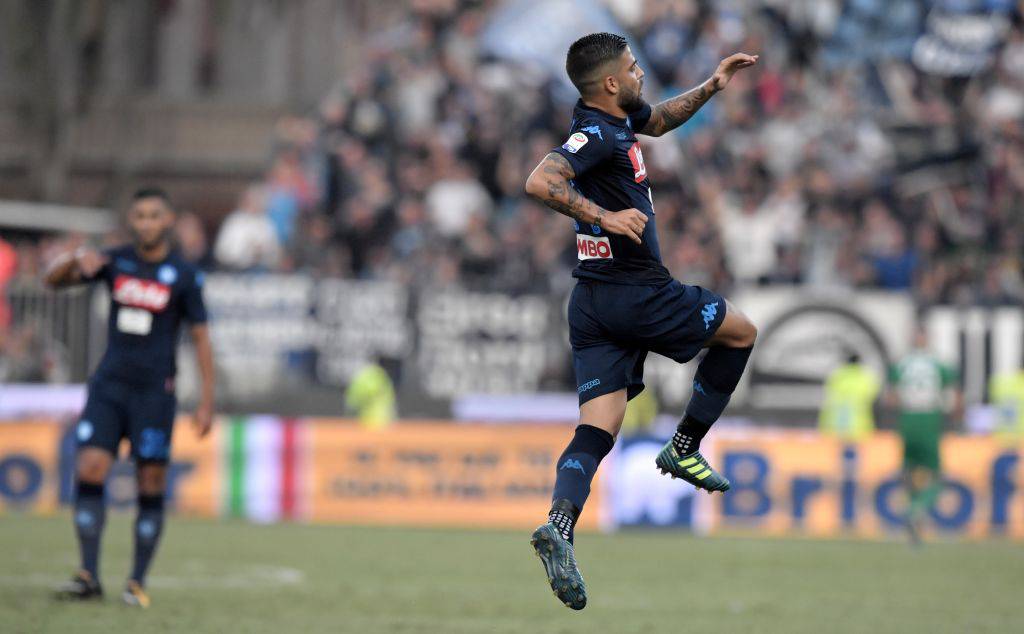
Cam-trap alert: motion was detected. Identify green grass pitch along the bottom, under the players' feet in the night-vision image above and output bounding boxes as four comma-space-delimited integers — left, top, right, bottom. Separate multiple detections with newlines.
0, 513, 1024, 634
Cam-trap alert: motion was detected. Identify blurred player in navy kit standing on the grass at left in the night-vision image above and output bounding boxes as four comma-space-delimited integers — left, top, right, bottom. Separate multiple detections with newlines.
46, 188, 214, 607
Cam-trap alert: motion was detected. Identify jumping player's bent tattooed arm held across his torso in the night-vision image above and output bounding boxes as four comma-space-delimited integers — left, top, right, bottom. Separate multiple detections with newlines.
525, 152, 647, 244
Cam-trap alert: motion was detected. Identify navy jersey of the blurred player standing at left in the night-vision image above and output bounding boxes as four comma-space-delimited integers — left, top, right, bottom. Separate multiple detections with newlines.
87, 245, 206, 385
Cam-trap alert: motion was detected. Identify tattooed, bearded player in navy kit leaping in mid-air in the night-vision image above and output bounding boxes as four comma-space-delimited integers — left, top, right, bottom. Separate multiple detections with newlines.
526, 33, 758, 609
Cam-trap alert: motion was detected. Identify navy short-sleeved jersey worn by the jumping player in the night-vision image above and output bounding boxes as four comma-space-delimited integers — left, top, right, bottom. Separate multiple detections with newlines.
554, 99, 672, 284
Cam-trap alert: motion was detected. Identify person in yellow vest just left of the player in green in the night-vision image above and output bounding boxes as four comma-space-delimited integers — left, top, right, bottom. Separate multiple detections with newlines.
818, 352, 882, 442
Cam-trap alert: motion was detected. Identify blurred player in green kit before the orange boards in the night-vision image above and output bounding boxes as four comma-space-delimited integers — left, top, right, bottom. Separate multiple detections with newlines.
889, 326, 963, 544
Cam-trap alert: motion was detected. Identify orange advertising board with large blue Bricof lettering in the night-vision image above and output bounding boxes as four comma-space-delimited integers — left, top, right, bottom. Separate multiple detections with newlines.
710, 430, 1024, 537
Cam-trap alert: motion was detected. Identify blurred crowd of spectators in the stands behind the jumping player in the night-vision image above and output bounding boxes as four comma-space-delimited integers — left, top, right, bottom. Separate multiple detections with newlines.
8, 0, 1024, 305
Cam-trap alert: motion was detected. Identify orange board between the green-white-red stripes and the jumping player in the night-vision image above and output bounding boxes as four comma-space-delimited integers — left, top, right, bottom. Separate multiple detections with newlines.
309, 420, 601, 529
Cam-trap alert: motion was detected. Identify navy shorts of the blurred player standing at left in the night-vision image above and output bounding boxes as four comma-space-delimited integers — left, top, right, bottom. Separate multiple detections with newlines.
75, 379, 177, 462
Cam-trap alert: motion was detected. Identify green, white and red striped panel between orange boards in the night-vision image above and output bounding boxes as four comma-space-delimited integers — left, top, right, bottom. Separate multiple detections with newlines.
222, 416, 307, 522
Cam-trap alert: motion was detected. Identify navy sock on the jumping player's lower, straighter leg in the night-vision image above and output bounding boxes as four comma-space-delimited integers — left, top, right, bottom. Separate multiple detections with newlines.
549, 425, 615, 542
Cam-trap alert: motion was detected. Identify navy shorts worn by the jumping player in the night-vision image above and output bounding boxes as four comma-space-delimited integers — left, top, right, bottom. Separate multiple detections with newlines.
568, 280, 725, 405
